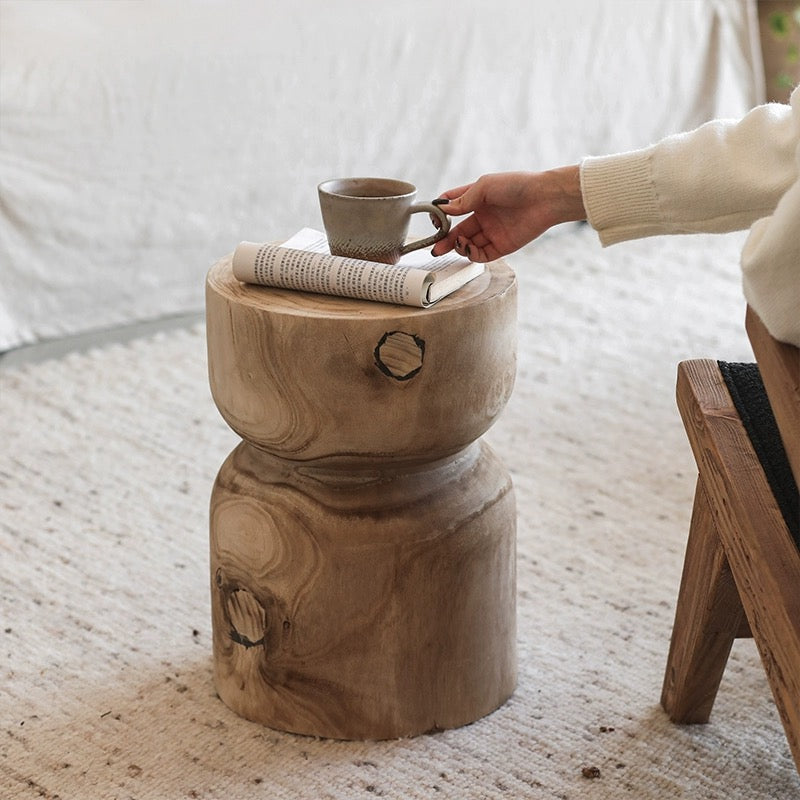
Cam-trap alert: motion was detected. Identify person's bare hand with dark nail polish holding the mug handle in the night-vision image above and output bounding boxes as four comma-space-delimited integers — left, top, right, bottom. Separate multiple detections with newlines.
431, 165, 586, 262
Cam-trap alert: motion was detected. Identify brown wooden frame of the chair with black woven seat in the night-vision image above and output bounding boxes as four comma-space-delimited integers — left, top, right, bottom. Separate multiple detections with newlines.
661, 309, 800, 771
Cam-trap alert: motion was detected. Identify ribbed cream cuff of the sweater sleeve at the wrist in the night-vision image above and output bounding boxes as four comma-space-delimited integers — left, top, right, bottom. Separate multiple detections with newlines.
580, 148, 664, 245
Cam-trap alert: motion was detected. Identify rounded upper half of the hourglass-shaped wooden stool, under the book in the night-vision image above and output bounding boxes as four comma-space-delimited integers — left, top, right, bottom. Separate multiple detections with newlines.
206, 253, 516, 462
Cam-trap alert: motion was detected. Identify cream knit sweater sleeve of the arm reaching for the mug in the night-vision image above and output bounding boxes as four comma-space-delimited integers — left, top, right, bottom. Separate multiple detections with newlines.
580, 92, 798, 245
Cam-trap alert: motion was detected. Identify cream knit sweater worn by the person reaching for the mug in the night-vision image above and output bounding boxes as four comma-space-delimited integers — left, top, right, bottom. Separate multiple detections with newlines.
581, 87, 800, 346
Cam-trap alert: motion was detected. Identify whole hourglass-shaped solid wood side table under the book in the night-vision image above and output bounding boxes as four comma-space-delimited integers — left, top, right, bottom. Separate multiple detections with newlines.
206, 257, 516, 739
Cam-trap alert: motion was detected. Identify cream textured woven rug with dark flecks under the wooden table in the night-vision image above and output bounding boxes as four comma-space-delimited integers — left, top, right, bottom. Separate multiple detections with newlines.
0, 227, 800, 800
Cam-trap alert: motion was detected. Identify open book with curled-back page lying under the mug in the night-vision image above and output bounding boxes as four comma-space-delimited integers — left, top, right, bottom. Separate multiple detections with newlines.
228, 228, 485, 308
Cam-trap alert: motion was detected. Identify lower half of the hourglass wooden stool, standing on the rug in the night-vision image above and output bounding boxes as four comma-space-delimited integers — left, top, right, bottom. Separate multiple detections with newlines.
211, 443, 516, 739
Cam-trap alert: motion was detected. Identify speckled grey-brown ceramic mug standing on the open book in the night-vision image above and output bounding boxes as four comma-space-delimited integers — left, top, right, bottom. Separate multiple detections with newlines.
317, 178, 450, 264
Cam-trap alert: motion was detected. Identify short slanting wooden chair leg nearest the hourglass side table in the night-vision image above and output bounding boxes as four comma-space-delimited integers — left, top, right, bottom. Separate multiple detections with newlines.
661, 477, 744, 724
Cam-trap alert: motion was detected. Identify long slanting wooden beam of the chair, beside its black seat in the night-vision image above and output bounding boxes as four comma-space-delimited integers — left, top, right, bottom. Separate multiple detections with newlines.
677, 360, 800, 770
